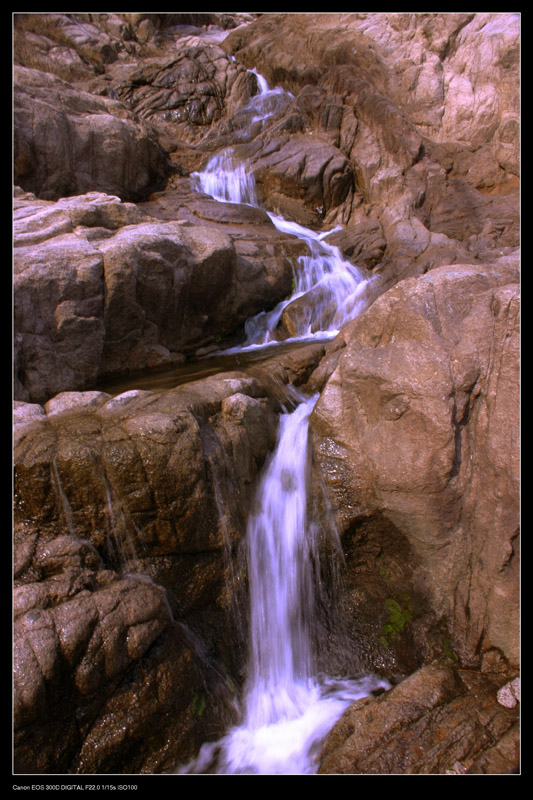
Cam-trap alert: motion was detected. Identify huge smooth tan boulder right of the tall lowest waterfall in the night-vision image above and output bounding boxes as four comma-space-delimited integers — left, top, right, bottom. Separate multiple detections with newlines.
311, 259, 519, 666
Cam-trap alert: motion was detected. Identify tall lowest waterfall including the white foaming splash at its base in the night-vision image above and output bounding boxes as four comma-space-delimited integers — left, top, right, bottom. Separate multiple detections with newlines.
180, 395, 389, 775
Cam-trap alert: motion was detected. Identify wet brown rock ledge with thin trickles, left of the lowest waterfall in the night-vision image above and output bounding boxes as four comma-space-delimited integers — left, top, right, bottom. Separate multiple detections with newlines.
15, 373, 278, 664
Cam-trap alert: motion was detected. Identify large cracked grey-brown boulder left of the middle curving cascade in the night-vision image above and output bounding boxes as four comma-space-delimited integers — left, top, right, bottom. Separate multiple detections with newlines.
14, 193, 301, 402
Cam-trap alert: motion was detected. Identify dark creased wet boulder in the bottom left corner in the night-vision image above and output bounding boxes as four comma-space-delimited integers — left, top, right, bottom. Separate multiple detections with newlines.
14, 564, 233, 773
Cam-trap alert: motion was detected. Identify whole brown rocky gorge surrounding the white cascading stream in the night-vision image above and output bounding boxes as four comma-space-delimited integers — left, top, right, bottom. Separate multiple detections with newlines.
13, 12, 520, 775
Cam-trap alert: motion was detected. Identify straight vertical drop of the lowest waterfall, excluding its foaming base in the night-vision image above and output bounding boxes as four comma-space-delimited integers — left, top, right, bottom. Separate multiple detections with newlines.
246, 397, 318, 712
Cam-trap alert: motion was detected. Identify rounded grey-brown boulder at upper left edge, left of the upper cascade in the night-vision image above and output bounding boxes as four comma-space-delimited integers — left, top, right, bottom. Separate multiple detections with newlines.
13, 66, 170, 201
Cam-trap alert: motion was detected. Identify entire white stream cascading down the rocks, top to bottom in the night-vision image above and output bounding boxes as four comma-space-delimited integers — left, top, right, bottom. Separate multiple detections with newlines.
180, 70, 389, 775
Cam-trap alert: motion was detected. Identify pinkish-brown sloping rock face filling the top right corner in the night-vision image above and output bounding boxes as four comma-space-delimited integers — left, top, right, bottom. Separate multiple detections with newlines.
224, 13, 519, 280
